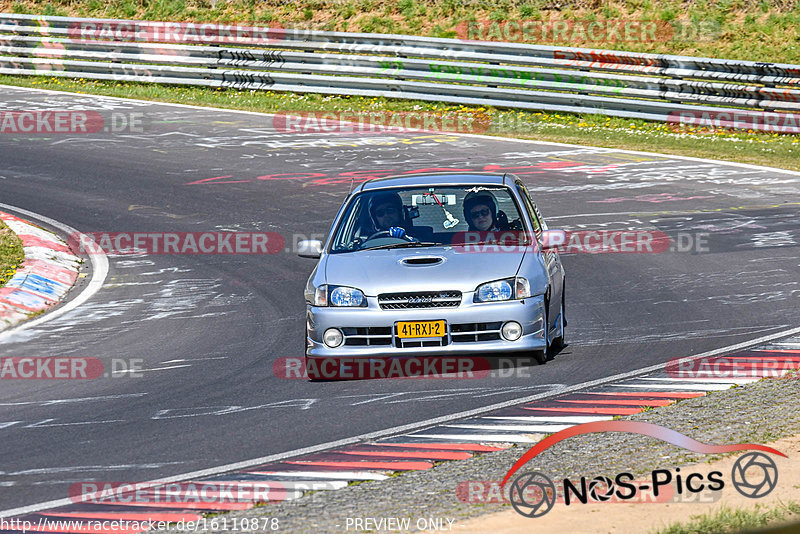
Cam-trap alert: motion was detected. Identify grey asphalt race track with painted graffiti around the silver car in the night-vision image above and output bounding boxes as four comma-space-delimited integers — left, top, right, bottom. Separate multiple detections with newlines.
0, 87, 800, 510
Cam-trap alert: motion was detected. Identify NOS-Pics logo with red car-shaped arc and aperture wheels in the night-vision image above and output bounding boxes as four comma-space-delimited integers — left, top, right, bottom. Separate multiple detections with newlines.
501, 421, 786, 518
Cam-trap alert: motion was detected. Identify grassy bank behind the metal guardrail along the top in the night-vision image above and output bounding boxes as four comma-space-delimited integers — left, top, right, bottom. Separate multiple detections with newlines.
0, 0, 800, 63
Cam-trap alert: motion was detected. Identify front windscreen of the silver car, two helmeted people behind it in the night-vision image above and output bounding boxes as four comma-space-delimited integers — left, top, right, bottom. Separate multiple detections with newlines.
330, 185, 526, 254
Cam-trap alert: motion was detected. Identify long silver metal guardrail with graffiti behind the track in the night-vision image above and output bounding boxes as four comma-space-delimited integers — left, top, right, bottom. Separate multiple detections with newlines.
0, 13, 800, 131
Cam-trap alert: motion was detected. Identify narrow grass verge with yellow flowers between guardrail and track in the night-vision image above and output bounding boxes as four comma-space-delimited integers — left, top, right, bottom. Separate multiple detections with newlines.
0, 76, 800, 170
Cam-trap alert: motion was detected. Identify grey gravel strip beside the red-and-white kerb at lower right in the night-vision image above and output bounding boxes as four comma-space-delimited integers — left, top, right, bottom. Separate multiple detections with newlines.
153, 374, 800, 534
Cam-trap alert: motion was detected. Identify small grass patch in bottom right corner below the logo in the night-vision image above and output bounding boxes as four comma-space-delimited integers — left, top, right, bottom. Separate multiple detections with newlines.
653, 502, 800, 534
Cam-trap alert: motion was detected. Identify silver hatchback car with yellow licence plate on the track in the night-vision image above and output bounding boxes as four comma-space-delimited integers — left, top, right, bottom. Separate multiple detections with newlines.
298, 173, 567, 374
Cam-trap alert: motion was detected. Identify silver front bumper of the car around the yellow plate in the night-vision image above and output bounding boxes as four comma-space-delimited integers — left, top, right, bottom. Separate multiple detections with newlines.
306, 294, 546, 358
